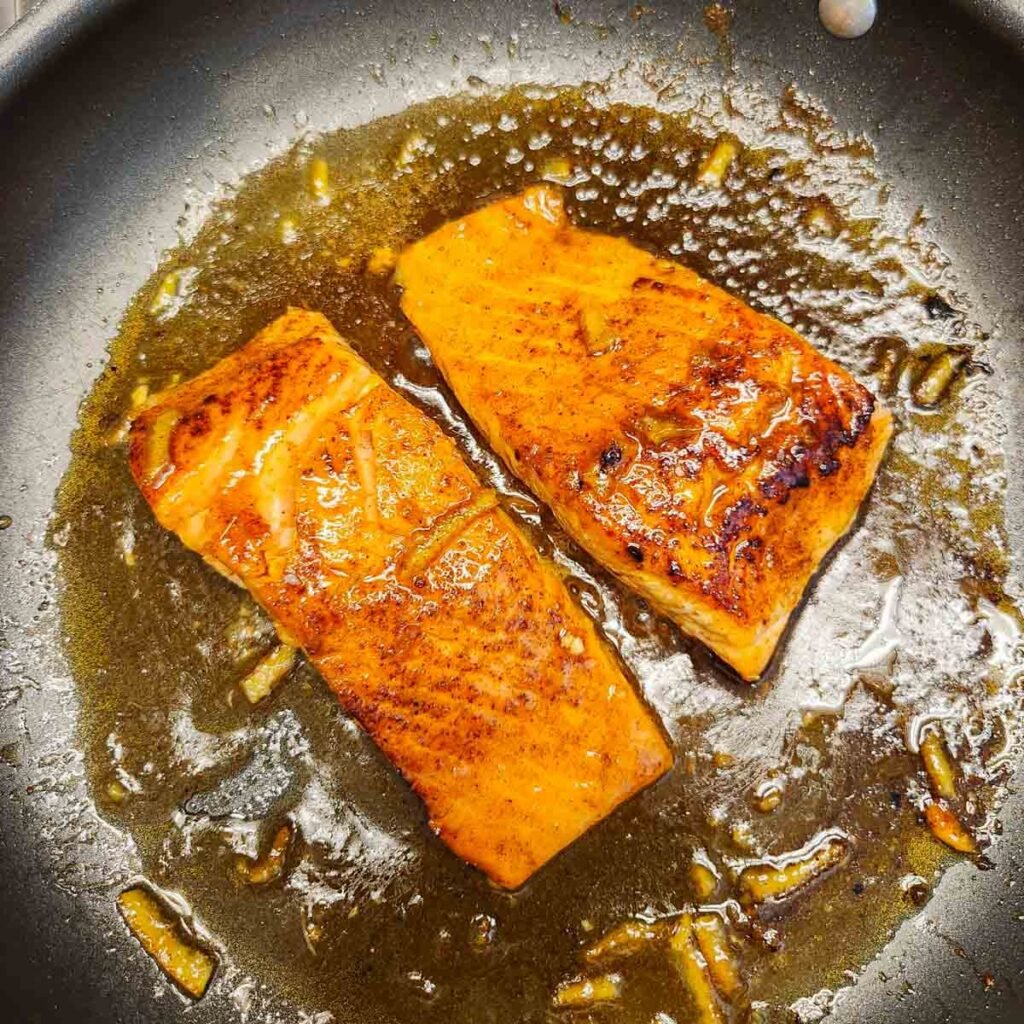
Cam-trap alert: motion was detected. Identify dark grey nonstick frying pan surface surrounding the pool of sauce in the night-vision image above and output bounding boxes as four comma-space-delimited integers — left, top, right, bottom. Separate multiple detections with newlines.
0, 0, 1024, 1024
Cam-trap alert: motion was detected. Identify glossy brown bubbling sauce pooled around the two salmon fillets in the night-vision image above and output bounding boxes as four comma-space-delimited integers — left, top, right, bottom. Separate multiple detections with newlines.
53, 83, 1019, 1024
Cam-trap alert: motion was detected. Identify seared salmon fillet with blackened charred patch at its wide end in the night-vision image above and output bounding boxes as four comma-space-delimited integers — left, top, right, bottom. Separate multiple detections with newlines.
397, 185, 892, 680
